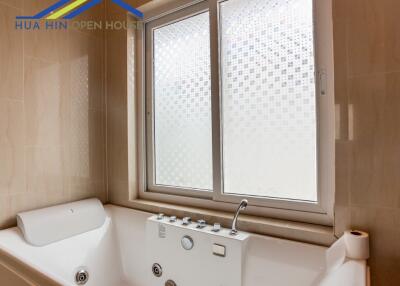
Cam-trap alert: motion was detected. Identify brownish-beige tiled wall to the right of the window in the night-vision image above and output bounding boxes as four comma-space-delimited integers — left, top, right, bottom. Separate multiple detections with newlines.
333, 0, 400, 286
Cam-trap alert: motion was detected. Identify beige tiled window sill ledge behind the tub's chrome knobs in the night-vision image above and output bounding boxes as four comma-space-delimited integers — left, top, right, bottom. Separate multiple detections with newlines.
118, 199, 335, 246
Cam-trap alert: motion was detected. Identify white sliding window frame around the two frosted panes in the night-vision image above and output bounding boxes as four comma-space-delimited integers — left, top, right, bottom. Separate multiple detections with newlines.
135, 0, 335, 225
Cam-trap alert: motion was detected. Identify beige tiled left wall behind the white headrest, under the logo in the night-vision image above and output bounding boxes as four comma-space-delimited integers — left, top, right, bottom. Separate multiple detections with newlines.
0, 0, 106, 228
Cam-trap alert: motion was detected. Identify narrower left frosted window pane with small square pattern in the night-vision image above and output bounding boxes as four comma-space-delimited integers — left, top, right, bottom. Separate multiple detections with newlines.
154, 13, 212, 190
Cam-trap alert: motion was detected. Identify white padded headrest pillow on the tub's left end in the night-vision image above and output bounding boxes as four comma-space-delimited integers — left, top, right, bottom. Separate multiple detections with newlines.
17, 199, 106, 246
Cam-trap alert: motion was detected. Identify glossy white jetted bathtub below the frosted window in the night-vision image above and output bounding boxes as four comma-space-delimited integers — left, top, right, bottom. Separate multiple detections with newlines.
0, 205, 367, 286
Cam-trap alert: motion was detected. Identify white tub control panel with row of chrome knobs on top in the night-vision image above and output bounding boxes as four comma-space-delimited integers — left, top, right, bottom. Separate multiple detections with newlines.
146, 214, 250, 286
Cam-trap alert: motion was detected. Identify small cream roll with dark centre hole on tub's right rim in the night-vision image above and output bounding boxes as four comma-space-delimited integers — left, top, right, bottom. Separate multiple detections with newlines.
343, 230, 369, 260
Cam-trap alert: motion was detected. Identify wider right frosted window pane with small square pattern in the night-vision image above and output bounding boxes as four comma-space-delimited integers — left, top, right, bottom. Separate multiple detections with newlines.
220, 0, 317, 201
